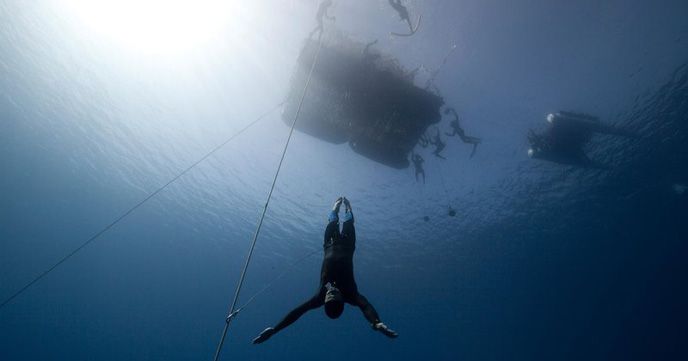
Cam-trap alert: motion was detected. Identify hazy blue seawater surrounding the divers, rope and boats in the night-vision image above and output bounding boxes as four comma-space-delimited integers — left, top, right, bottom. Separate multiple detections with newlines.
0, 0, 688, 361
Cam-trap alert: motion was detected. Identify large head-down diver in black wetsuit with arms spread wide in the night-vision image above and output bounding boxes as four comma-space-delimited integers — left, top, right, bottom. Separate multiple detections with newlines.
253, 197, 397, 344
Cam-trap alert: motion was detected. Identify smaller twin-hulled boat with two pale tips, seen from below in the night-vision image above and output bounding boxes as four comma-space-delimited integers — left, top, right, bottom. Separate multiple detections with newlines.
528, 111, 635, 169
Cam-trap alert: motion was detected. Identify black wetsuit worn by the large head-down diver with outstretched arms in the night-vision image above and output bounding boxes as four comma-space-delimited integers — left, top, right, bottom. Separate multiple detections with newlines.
275, 211, 380, 331
